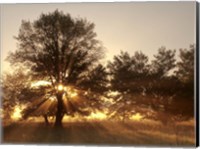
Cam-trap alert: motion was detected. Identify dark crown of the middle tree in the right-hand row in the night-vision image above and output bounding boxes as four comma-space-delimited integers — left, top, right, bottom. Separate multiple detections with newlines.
149, 47, 177, 95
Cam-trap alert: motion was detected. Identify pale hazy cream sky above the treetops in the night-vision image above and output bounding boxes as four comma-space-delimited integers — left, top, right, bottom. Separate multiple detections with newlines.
1, 2, 196, 71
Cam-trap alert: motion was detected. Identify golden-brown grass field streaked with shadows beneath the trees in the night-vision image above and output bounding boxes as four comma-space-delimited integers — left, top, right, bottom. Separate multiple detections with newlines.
2, 120, 195, 146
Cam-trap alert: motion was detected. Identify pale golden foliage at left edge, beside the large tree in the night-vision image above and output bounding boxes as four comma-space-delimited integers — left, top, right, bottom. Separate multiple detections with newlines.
1, 69, 33, 118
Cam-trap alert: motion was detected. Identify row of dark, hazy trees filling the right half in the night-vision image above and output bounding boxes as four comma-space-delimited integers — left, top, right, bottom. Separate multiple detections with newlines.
108, 46, 194, 124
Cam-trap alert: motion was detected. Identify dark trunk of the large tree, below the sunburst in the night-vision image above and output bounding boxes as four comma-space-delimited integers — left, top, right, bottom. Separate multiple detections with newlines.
54, 93, 63, 127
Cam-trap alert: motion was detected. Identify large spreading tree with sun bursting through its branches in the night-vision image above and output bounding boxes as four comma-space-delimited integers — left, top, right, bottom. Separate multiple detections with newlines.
8, 10, 102, 126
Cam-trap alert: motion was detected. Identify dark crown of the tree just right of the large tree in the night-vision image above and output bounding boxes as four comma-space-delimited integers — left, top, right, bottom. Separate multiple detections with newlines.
108, 52, 149, 91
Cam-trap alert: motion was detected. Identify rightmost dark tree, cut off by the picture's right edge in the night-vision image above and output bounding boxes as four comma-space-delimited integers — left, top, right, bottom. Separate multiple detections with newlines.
176, 45, 196, 113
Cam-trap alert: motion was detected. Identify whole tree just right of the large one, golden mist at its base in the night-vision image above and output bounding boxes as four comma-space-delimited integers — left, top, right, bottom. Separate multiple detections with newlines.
108, 51, 149, 121
